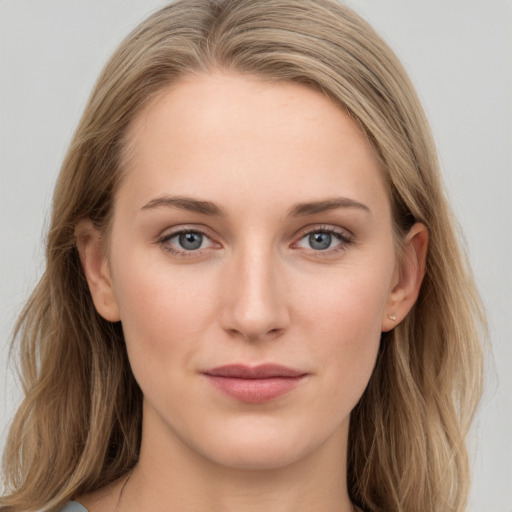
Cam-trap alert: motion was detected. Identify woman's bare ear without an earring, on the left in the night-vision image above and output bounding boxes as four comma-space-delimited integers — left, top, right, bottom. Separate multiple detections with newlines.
75, 220, 120, 322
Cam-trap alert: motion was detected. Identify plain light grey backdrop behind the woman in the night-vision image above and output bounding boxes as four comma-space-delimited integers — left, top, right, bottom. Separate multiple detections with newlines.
0, 0, 512, 512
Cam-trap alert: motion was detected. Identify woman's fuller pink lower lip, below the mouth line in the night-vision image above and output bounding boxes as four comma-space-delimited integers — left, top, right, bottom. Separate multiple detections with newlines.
206, 375, 304, 404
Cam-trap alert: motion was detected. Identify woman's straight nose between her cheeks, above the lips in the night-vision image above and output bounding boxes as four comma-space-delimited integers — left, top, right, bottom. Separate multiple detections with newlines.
221, 245, 290, 341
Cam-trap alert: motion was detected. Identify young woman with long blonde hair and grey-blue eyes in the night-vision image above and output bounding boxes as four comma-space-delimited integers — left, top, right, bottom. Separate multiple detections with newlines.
0, 0, 483, 512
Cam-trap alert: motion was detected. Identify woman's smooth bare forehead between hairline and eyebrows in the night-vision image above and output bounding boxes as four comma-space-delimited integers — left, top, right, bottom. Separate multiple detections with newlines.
119, 73, 387, 216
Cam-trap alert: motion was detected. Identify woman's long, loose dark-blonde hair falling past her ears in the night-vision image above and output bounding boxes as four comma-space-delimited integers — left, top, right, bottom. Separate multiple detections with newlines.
0, 0, 485, 512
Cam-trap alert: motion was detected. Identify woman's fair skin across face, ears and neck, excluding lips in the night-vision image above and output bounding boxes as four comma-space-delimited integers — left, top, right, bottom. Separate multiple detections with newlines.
77, 72, 427, 512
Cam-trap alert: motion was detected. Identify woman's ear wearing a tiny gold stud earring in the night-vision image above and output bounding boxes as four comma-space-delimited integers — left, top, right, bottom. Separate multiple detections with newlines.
382, 223, 428, 332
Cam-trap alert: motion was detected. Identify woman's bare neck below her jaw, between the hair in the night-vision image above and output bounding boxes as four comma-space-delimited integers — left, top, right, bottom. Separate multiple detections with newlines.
118, 404, 354, 512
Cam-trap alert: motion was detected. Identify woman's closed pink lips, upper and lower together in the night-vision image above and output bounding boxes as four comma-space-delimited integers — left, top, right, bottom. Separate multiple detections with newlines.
202, 364, 307, 404
